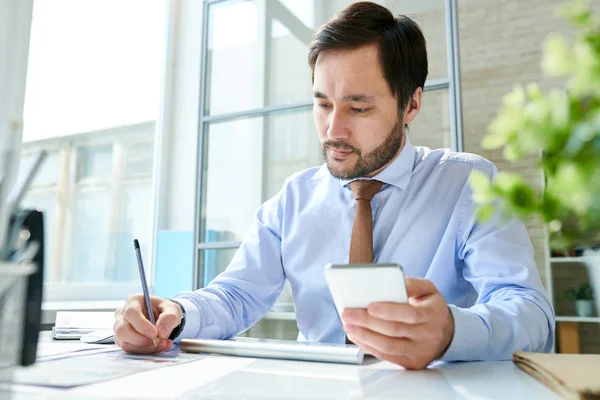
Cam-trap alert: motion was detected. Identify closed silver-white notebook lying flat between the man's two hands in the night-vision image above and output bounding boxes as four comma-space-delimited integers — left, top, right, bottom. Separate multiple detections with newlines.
179, 337, 364, 364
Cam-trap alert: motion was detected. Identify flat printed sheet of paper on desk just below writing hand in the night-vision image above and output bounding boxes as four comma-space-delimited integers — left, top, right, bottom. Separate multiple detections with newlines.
14, 349, 201, 388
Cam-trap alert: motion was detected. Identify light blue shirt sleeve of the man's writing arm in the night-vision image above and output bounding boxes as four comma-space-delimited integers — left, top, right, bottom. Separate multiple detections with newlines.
174, 190, 285, 342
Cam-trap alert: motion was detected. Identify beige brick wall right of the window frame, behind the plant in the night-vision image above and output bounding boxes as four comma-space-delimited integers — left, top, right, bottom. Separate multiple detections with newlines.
458, 0, 600, 353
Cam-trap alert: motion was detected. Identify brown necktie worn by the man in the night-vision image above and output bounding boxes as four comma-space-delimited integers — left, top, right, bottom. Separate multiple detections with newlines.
346, 179, 383, 344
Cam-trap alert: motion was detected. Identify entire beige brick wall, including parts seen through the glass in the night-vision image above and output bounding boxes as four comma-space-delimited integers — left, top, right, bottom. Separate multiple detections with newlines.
412, 0, 600, 353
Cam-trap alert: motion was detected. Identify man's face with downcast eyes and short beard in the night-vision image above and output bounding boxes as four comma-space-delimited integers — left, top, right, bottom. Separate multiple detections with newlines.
313, 45, 420, 179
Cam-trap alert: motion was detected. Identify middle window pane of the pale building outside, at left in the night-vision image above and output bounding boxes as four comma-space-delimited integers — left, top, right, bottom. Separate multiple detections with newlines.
63, 191, 110, 283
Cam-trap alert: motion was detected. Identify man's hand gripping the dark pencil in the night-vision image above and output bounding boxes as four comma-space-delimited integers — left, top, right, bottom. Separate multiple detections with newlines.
114, 293, 182, 354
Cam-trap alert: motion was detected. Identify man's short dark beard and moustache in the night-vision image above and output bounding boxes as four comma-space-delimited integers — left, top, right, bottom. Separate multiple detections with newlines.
321, 122, 404, 180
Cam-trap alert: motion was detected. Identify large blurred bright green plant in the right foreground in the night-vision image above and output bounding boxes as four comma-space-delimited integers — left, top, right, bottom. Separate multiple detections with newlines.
471, 0, 600, 249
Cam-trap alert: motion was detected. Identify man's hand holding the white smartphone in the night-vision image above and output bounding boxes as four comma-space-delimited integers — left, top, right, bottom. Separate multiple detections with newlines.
342, 277, 454, 369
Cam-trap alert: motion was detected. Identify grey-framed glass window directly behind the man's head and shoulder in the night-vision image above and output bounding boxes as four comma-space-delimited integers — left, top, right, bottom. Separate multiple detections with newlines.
196, 0, 461, 287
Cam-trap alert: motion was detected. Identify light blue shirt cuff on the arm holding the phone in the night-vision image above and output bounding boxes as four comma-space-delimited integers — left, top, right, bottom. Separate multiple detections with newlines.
440, 304, 489, 361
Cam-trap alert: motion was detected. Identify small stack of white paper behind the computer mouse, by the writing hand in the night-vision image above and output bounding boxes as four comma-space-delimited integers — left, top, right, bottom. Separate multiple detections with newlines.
52, 311, 115, 339
